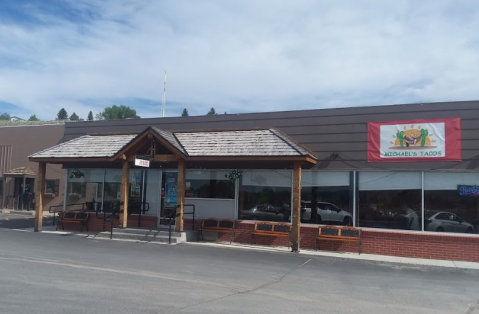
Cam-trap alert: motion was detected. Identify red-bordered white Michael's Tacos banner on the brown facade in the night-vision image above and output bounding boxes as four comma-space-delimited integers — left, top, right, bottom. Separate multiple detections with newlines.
368, 118, 462, 162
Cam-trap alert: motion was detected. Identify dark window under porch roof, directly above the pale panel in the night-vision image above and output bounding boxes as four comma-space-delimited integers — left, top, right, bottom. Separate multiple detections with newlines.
185, 170, 235, 199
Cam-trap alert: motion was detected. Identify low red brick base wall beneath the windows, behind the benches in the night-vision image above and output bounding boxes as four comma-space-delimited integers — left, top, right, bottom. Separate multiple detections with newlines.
61, 214, 479, 262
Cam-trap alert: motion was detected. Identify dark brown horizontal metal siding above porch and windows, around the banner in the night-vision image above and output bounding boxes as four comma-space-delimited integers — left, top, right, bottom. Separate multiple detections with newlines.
64, 101, 479, 171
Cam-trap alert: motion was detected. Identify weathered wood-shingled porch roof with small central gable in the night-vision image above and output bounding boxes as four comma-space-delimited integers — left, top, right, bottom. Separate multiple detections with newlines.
29, 127, 317, 163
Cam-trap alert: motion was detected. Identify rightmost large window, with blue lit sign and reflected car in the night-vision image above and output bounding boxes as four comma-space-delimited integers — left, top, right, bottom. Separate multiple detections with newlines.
424, 172, 479, 233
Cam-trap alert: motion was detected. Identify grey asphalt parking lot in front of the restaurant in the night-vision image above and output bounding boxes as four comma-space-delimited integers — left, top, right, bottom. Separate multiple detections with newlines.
0, 224, 479, 314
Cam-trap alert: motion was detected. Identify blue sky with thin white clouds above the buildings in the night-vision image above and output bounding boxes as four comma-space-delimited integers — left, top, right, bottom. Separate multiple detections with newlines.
0, 0, 479, 119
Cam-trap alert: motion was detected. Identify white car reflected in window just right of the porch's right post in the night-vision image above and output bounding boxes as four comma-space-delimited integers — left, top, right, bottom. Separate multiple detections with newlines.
301, 201, 353, 226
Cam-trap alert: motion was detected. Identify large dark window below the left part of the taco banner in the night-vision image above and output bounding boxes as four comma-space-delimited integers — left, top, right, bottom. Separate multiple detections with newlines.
357, 172, 422, 230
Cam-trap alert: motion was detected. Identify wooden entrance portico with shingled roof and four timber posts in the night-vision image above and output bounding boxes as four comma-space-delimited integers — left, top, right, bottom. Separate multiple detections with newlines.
30, 127, 317, 251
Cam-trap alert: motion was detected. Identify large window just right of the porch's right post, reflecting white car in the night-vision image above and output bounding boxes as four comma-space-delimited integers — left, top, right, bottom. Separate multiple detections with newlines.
301, 171, 353, 225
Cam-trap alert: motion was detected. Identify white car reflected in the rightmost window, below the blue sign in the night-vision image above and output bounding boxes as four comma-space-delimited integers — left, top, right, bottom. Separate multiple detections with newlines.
424, 210, 474, 233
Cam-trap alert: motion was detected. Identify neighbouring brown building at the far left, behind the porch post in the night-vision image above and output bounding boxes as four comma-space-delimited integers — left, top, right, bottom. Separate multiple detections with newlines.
0, 121, 66, 210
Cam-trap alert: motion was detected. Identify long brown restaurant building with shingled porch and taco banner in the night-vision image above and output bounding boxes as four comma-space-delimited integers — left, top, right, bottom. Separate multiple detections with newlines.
30, 101, 479, 262
